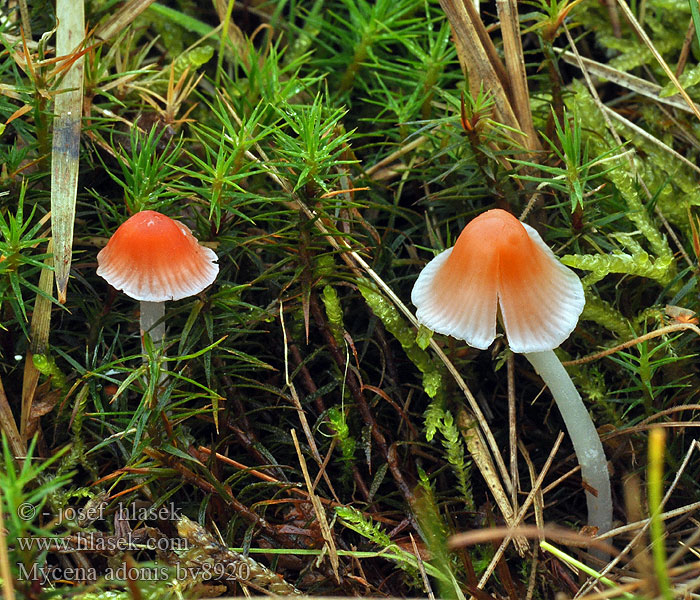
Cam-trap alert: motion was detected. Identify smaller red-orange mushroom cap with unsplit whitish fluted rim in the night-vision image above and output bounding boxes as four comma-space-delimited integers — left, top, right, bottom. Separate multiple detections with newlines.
97, 210, 219, 302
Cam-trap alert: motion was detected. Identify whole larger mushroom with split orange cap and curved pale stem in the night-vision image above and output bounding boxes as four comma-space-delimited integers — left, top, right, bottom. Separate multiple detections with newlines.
411, 209, 612, 533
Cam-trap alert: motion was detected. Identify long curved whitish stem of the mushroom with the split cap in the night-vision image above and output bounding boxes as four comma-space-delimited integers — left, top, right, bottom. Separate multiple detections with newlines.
525, 350, 612, 534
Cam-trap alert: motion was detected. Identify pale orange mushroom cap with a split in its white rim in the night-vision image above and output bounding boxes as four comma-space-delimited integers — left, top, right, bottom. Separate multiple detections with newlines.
411, 209, 586, 352
